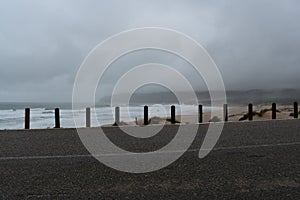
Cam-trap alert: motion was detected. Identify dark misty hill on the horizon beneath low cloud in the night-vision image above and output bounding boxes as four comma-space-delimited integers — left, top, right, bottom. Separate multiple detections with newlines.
97, 89, 300, 105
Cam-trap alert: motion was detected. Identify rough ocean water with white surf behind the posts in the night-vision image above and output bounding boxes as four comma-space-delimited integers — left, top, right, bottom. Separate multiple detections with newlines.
0, 103, 205, 130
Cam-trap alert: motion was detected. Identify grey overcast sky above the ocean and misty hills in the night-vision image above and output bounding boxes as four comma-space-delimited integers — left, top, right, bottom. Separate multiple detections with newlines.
0, 0, 300, 101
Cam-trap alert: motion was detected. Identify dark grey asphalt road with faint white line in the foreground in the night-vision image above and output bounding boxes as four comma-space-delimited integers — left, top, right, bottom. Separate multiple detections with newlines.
0, 120, 300, 199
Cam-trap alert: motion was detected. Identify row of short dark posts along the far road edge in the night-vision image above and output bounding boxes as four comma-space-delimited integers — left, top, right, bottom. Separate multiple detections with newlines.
25, 102, 298, 129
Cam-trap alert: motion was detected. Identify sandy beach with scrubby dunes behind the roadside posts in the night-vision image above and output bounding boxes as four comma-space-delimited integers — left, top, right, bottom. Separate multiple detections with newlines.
0, 104, 300, 130
